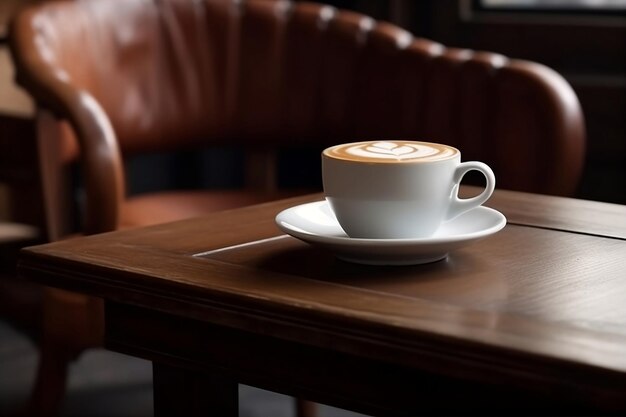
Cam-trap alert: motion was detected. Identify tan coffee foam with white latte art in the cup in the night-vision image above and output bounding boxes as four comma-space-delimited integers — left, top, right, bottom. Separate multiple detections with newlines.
324, 140, 459, 162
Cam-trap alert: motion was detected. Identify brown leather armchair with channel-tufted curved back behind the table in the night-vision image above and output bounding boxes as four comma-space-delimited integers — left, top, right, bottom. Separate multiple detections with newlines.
10, 0, 585, 412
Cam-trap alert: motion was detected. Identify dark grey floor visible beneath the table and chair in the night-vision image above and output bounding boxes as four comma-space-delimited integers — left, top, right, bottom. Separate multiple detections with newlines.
0, 320, 360, 417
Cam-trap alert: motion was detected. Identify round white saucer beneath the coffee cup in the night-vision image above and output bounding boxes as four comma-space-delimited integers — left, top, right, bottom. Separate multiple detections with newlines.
276, 201, 506, 265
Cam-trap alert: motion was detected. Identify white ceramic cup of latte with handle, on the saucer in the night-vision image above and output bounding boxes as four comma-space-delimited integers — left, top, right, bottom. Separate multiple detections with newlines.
322, 140, 496, 239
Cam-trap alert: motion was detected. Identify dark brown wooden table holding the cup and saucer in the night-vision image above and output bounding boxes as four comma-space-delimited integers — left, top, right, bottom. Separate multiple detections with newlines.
20, 190, 626, 416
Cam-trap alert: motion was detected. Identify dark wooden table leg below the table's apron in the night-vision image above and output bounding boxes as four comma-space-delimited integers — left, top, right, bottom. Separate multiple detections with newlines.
152, 363, 239, 417
